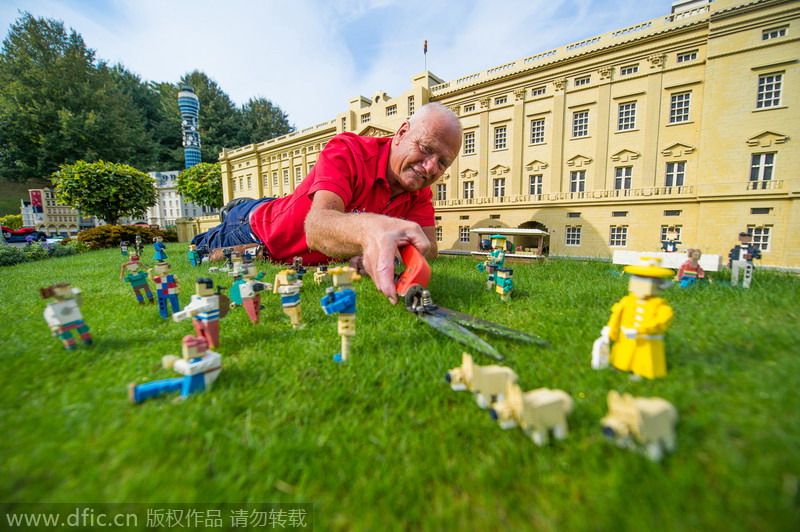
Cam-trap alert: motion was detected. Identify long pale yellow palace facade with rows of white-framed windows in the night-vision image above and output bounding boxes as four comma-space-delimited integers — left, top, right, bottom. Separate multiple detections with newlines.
220, 0, 800, 268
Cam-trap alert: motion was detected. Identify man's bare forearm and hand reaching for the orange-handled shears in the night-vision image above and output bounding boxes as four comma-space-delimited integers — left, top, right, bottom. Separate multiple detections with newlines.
305, 190, 435, 304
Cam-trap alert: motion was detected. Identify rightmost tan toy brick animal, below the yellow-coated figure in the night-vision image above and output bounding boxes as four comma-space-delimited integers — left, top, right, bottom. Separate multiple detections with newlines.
600, 390, 678, 462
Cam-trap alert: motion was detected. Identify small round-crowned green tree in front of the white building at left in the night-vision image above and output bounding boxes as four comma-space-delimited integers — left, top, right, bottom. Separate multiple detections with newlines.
52, 161, 158, 225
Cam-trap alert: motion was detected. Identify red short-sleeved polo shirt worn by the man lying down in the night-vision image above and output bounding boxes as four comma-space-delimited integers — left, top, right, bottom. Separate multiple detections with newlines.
250, 133, 434, 264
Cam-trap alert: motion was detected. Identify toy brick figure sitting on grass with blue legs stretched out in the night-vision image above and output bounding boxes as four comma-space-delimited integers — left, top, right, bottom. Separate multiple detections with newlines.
128, 335, 222, 403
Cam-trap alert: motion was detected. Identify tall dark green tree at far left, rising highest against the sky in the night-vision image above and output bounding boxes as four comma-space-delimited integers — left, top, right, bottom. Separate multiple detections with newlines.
0, 13, 153, 181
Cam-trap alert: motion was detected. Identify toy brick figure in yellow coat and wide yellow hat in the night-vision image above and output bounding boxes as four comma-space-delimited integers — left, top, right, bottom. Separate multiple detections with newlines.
592, 257, 673, 379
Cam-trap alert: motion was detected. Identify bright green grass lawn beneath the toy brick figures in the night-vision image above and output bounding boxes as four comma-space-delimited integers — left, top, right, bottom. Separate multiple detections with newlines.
0, 244, 800, 531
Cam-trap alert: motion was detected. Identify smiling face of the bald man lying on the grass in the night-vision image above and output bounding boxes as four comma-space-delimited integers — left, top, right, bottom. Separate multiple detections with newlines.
388, 113, 461, 195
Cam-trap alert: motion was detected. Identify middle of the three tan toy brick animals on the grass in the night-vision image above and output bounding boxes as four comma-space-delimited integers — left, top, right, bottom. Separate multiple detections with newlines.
489, 382, 573, 447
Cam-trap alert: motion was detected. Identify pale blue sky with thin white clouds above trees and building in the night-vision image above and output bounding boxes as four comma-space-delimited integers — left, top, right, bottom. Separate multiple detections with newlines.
0, 0, 671, 128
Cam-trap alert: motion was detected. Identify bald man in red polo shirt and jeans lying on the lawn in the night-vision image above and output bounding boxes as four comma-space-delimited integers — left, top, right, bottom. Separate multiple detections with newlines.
192, 103, 462, 303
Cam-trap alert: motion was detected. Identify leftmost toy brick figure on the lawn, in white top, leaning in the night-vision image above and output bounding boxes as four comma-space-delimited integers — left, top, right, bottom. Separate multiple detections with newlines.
39, 283, 92, 350
